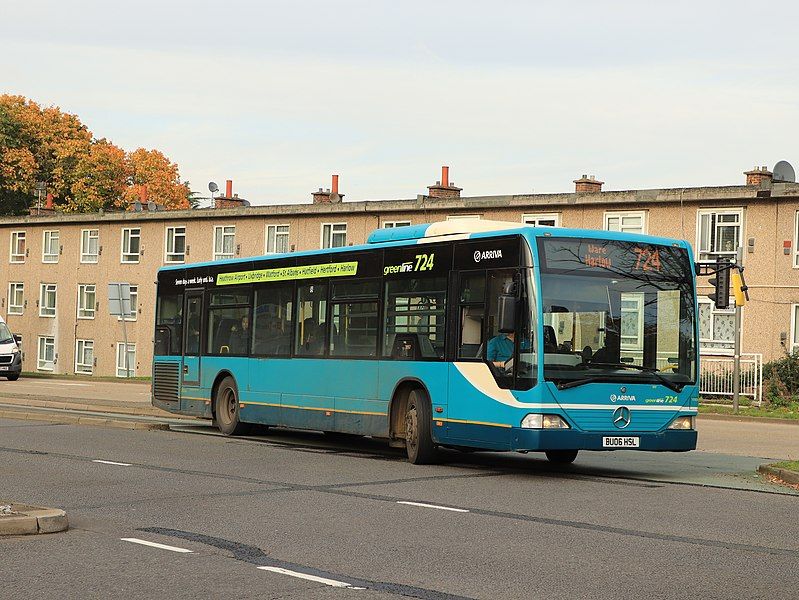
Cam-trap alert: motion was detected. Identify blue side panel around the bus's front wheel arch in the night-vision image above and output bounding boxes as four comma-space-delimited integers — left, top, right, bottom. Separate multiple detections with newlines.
378, 360, 449, 442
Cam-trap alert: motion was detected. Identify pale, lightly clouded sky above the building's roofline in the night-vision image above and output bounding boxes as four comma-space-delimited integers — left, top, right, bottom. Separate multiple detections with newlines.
0, 0, 799, 204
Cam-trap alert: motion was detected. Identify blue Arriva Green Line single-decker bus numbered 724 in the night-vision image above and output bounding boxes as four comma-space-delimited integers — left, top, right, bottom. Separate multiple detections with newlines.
152, 220, 699, 464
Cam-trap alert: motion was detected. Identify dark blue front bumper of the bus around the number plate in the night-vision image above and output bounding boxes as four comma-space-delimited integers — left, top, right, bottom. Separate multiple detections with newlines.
511, 427, 696, 452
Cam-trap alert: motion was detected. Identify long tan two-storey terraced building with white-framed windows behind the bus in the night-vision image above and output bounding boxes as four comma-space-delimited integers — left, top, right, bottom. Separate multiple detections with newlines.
0, 167, 799, 398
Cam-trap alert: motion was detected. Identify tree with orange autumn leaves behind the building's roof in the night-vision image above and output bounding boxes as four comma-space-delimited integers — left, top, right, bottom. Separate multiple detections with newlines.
0, 95, 189, 214
